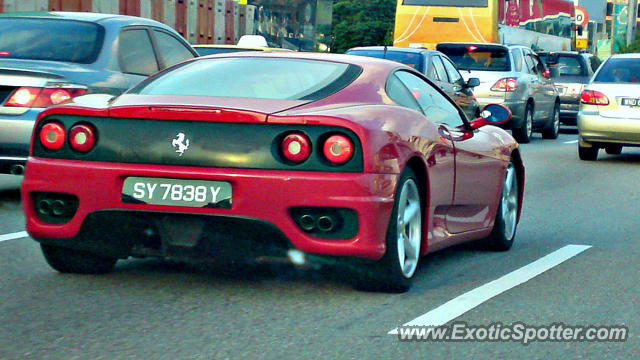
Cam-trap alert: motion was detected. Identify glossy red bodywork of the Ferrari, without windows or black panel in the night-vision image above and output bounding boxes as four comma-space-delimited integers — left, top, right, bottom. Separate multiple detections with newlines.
22, 53, 524, 260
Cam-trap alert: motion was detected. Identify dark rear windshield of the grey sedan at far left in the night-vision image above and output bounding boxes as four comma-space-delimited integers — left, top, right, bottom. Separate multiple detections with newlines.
0, 17, 104, 64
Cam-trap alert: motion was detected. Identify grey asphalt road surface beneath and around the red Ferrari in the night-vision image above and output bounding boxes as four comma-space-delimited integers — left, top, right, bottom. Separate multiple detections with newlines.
0, 133, 640, 359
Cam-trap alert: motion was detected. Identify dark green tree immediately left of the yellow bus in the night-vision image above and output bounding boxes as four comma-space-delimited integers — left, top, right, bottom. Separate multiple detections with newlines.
331, 0, 396, 53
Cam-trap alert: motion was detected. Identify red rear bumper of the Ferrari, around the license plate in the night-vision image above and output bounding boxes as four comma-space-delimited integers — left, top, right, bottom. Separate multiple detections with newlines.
22, 157, 398, 259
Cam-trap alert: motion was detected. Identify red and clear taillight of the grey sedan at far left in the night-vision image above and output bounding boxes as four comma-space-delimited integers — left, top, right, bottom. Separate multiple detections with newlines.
4, 87, 87, 107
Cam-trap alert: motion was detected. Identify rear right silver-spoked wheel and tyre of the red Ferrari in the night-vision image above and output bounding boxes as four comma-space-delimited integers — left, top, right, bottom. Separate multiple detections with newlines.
356, 168, 423, 293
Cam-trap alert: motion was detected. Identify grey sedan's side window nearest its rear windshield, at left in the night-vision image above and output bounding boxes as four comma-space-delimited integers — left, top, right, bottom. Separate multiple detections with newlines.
118, 29, 158, 76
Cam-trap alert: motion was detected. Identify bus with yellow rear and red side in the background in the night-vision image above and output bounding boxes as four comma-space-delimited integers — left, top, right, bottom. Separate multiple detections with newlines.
393, 0, 575, 50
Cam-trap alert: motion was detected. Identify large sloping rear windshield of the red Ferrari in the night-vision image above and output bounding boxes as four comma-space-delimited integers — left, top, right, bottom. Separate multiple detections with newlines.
129, 57, 361, 100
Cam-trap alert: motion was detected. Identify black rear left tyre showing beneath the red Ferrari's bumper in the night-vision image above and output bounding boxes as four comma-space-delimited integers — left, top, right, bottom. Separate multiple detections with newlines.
40, 244, 118, 274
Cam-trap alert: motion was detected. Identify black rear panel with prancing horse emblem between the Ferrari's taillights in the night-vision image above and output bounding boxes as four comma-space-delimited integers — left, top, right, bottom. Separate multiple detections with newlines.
33, 115, 364, 172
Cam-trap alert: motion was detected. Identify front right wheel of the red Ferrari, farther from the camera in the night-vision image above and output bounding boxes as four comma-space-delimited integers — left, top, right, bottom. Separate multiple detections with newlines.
486, 162, 520, 251
